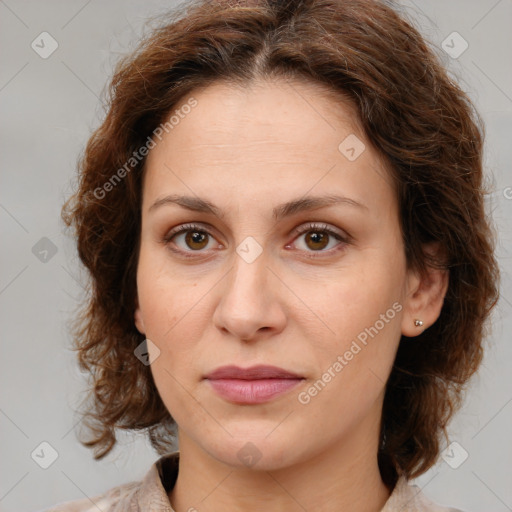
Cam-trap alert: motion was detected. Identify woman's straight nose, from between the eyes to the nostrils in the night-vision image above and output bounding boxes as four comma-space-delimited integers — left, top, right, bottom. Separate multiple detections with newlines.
213, 246, 286, 341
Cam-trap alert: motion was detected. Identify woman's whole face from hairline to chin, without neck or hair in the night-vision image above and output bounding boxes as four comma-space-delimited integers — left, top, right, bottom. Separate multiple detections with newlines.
135, 80, 424, 469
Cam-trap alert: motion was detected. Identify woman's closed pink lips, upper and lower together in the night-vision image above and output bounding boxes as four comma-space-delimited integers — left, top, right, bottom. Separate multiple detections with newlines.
205, 365, 303, 404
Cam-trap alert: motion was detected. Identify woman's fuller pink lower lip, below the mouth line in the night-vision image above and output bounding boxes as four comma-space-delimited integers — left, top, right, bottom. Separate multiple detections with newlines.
208, 379, 302, 404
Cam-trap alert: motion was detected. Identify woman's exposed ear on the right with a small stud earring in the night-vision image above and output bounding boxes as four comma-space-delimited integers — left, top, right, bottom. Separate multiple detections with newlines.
402, 243, 449, 337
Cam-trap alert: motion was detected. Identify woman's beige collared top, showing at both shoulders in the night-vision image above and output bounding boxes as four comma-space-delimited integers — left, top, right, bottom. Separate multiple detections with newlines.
41, 451, 462, 512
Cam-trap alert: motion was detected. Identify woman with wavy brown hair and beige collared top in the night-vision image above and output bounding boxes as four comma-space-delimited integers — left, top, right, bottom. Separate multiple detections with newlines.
46, 0, 498, 512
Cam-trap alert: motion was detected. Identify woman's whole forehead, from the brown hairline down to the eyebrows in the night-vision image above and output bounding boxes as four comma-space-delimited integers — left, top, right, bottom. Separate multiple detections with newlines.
144, 79, 392, 215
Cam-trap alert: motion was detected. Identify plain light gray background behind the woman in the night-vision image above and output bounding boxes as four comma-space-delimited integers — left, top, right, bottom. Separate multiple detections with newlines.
0, 0, 512, 512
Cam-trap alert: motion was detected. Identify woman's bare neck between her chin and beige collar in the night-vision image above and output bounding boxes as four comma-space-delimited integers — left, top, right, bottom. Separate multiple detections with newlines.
169, 426, 390, 512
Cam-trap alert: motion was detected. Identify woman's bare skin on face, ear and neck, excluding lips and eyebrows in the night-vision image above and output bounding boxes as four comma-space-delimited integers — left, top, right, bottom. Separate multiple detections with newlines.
135, 79, 448, 512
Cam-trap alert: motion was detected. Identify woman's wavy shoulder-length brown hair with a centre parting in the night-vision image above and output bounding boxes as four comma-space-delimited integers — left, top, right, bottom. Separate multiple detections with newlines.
62, 0, 499, 485
